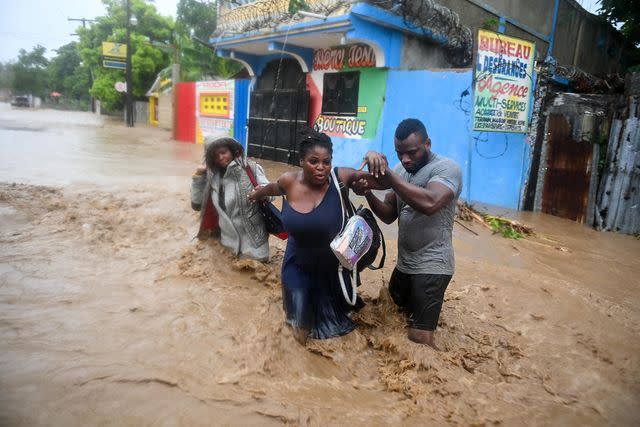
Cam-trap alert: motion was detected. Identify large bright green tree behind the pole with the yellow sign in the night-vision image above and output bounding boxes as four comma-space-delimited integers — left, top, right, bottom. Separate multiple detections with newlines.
77, 0, 174, 110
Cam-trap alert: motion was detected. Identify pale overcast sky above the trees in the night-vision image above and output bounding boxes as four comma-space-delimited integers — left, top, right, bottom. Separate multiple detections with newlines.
0, 0, 598, 62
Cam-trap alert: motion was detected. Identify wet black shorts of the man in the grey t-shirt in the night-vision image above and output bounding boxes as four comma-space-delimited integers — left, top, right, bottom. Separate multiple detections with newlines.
389, 268, 451, 331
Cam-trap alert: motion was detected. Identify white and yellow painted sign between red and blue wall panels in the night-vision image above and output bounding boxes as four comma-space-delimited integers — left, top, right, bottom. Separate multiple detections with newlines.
196, 80, 235, 143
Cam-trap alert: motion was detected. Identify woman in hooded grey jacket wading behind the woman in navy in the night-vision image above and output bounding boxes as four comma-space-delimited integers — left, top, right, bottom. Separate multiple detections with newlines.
191, 137, 269, 261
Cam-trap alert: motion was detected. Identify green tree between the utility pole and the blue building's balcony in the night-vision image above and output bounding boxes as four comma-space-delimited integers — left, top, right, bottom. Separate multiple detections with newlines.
175, 0, 242, 81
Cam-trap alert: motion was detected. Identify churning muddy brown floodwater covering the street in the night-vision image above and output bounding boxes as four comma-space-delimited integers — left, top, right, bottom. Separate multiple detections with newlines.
0, 104, 640, 426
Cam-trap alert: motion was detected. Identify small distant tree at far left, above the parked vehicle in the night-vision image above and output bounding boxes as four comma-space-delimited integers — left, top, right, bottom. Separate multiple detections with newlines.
11, 45, 49, 97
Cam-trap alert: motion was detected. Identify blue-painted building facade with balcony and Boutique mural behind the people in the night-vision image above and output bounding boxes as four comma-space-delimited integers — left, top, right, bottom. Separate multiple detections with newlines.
210, 0, 618, 209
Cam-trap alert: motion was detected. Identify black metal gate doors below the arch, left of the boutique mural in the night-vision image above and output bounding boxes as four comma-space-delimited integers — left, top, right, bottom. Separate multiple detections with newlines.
247, 89, 309, 165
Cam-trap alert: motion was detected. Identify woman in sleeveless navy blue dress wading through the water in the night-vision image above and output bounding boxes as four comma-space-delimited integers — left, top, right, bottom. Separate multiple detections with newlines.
249, 129, 388, 344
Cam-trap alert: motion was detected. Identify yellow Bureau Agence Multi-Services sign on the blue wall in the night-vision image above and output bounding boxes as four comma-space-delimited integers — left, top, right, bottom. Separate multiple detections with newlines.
473, 30, 535, 133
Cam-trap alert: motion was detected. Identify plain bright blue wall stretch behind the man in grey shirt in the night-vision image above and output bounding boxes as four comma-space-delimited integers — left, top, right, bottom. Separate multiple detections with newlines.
332, 69, 529, 209
